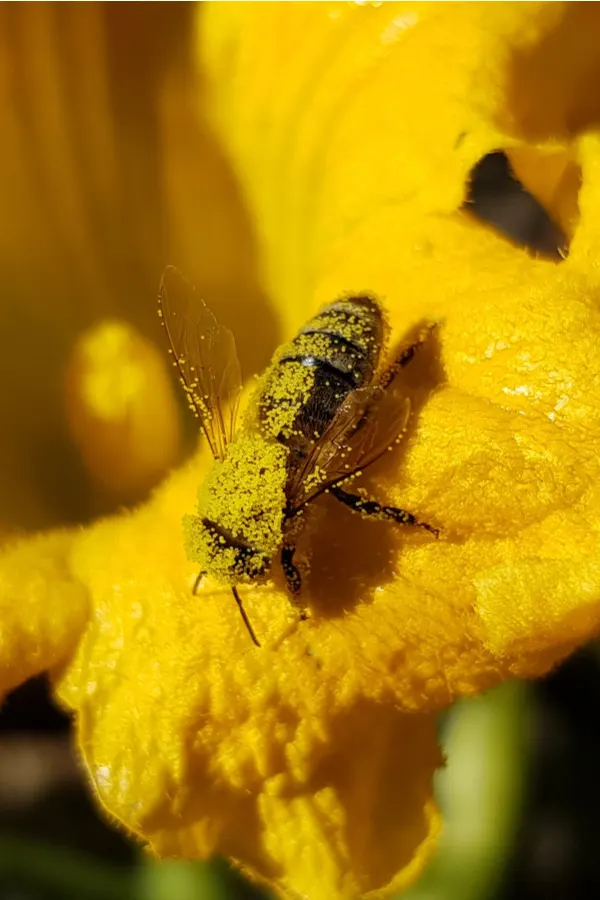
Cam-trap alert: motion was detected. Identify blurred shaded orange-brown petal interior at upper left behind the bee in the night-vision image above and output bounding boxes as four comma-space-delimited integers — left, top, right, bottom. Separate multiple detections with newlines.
0, 3, 258, 529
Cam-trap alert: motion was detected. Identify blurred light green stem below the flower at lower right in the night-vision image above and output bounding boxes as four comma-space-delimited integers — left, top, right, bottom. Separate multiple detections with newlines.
402, 682, 531, 900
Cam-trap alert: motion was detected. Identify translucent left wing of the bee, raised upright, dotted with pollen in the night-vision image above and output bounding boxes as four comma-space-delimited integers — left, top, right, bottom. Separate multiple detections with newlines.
158, 266, 242, 459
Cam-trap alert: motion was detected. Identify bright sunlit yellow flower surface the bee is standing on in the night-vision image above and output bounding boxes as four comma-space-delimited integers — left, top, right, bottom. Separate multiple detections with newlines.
0, 3, 600, 900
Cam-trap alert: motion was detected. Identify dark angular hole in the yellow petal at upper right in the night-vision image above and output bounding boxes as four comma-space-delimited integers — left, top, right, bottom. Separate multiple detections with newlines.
465, 151, 568, 262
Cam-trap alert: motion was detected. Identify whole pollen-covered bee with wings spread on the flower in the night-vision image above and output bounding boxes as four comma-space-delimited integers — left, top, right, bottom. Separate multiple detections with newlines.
159, 267, 438, 646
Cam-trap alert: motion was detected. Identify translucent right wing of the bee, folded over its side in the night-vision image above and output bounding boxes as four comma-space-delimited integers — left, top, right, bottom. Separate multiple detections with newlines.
288, 385, 410, 511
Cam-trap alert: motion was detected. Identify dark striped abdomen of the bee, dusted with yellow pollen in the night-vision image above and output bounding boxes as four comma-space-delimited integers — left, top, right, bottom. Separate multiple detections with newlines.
259, 297, 384, 457
